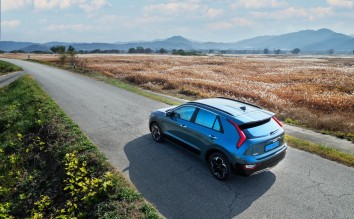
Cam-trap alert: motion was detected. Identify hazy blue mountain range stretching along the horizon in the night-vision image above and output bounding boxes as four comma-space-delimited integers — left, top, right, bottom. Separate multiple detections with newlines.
0, 29, 354, 52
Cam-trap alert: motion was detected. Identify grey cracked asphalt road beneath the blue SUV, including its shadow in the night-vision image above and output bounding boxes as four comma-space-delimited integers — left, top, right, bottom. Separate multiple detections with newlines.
2, 60, 354, 219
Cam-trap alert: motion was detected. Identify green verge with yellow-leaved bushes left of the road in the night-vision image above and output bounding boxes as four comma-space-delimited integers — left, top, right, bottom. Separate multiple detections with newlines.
0, 75, 159, 218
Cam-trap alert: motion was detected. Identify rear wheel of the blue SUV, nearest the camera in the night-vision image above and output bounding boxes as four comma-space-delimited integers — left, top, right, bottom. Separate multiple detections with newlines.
208, 152, 231, 181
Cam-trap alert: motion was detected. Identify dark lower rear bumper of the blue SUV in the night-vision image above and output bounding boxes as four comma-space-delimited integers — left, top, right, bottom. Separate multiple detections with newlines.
234, 150, 286, 176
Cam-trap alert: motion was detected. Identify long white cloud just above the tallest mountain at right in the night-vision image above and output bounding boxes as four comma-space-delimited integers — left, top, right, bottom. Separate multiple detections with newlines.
251, 7, 333, 20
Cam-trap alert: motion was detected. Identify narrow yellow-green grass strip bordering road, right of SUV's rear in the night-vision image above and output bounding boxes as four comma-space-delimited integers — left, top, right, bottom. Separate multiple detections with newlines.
286, 135, 354, 167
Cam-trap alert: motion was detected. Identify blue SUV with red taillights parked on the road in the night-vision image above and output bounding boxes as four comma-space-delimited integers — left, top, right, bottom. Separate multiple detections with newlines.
149, 97, 287, 180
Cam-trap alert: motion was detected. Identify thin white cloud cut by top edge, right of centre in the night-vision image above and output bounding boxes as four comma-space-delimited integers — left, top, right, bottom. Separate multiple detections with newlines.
230, 0, 287, 9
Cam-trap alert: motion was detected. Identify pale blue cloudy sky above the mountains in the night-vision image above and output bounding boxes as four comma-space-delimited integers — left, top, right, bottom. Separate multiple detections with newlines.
1, 0, 354, 42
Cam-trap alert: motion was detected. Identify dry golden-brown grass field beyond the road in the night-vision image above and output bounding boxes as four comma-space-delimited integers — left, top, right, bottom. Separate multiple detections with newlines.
3, 55, 354, 139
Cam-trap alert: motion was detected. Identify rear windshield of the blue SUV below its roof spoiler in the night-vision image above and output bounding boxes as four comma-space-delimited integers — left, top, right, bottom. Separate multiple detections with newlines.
240, 119, 281, 138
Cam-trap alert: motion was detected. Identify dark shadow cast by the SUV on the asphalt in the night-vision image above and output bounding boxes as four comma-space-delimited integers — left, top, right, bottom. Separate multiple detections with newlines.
123, 135, 276, 218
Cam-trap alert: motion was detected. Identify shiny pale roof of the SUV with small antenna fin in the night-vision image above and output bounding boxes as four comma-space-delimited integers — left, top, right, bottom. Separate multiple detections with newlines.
190, 97, 262, 117
